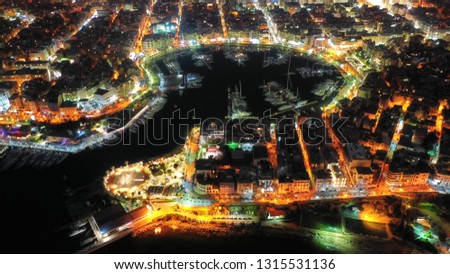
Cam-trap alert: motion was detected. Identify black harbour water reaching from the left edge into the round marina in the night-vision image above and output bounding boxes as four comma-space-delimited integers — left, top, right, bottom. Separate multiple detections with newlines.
0, 48, 338, 253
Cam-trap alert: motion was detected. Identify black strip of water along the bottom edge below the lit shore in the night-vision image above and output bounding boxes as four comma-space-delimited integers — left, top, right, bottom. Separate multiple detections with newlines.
98, 228, 328, 254
